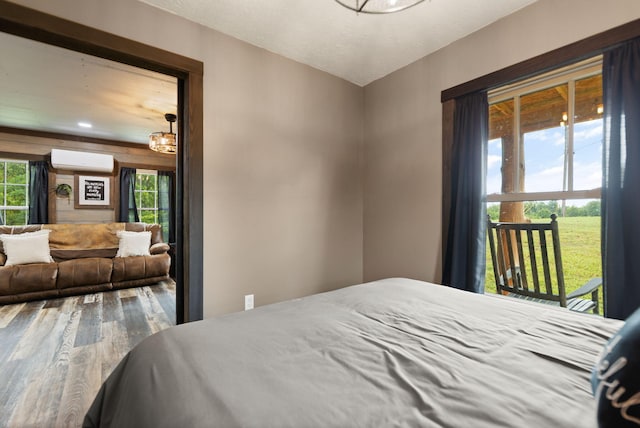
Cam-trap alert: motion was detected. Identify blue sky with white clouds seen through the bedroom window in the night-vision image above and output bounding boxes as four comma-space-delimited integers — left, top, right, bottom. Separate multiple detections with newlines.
487, 119, 602, 206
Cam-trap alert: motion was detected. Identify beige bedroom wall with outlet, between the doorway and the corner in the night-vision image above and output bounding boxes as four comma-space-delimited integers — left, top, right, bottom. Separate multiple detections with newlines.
7, 0, 363, 317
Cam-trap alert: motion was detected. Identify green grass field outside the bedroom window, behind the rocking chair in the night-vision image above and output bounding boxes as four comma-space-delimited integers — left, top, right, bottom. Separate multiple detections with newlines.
485, 217, 602, 313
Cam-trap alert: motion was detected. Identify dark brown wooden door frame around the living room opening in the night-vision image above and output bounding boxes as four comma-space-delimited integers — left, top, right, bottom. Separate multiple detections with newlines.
0, 0, 204, 323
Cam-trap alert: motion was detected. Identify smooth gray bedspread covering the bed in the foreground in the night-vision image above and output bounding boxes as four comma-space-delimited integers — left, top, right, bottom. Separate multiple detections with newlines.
85, 279, 621, 428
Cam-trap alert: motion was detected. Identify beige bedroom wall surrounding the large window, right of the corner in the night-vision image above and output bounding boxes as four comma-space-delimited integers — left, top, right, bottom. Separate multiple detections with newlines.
364, 0, 640, 282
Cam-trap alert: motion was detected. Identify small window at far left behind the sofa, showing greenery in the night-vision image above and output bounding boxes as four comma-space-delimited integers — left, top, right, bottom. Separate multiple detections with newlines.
0, 159, 29, 226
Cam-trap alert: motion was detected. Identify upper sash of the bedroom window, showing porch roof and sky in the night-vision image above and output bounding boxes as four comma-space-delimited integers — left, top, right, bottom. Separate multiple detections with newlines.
487, 57, 603, 217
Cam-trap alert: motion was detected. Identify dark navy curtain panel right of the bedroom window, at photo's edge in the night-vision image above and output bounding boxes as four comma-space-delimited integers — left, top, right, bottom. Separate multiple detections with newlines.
602, 39, 640, 319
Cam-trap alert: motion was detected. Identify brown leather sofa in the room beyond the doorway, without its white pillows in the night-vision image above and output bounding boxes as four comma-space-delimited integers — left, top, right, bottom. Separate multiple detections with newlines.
0, 223, 171, 304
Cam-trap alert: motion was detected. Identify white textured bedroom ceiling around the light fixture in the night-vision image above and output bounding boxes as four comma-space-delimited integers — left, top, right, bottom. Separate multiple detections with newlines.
141, 0, 535, 86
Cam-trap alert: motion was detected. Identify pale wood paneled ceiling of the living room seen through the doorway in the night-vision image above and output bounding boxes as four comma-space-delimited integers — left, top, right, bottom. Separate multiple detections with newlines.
0, 32, 178, 144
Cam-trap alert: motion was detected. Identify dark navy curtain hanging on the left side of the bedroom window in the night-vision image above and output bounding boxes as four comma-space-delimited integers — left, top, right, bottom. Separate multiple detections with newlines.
442, 92, 489, 293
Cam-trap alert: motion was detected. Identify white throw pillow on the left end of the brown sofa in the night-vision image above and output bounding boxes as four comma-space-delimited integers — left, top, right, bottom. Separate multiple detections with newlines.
0, 230, 53, 266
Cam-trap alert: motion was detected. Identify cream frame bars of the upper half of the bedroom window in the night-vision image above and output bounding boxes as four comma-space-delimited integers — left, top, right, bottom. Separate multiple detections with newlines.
487, 55, 602, 202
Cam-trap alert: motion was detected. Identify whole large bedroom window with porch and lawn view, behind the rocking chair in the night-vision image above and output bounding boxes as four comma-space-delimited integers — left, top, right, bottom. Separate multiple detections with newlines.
485, 57, 603, 309
